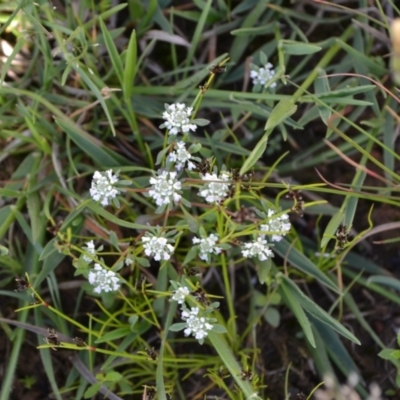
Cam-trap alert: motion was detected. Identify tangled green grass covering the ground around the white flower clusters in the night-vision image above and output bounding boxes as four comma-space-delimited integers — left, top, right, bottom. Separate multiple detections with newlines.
0, 0, 400, 400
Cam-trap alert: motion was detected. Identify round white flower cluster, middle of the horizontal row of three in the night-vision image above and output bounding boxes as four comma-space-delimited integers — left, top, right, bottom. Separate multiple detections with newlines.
149, 171, 182, 206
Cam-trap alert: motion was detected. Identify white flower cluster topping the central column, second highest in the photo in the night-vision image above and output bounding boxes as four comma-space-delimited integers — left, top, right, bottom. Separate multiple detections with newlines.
160, 103, 197, 135
